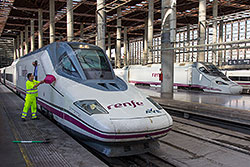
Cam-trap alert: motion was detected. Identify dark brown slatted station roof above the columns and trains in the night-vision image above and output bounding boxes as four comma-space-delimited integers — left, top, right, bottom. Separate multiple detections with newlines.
0, 0, 250, 52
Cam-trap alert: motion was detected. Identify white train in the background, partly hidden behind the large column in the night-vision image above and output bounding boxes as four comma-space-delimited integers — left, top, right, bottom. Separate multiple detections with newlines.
114, 62, 242, 94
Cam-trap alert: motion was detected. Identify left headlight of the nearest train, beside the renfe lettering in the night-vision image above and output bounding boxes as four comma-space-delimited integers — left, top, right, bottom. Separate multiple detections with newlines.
74, 100, 108, 115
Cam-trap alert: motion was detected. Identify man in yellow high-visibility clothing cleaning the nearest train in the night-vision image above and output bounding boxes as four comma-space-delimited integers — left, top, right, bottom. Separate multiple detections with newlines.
21, 73, 44, 121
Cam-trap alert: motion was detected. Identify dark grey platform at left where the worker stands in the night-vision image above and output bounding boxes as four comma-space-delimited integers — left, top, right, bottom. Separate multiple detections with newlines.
0, 83, 107, 167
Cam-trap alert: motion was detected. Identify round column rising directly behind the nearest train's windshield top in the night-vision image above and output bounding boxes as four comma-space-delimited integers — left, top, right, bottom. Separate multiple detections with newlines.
97, 0, 106, 52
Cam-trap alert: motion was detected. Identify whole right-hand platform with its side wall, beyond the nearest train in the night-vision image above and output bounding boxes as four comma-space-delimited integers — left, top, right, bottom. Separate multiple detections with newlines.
138, 87, 250, 125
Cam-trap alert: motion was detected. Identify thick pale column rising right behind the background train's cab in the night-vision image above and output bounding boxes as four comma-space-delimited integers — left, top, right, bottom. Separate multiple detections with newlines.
198, 0, 206, 62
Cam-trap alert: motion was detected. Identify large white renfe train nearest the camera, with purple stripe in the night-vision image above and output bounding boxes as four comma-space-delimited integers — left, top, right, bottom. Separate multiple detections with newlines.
0, 42, 173, 156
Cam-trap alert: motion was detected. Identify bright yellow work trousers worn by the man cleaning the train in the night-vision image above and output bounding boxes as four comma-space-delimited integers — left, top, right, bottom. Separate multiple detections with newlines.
22, 96, 37, 119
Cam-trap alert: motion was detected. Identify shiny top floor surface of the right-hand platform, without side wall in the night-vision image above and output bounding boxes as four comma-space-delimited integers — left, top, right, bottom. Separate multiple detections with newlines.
138, 87, 250, 110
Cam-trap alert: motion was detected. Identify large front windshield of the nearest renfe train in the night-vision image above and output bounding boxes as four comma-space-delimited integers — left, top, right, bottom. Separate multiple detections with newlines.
74, 49, 114, 79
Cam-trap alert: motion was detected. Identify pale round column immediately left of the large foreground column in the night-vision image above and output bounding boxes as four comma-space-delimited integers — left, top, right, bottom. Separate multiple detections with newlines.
148, 0, 154, 64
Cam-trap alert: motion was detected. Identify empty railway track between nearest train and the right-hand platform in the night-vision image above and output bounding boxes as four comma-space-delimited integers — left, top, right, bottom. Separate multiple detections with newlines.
160, 105, 250, 155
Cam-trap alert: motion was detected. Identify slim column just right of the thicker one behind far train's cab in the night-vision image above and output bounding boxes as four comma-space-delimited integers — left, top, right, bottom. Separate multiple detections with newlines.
212, 0, 218, 65
